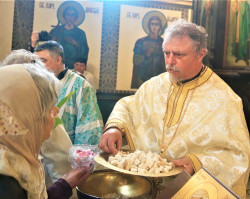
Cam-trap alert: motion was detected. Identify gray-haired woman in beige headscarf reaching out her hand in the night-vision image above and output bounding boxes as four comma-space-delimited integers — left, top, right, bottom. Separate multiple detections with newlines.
0, 64, 89, 199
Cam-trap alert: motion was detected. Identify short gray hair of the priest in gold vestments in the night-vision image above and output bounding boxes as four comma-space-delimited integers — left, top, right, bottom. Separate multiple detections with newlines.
162, 19, 208, 53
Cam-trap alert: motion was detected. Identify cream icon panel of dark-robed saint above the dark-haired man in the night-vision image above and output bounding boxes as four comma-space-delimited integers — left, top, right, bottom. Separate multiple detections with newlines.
33, 0, 103, 89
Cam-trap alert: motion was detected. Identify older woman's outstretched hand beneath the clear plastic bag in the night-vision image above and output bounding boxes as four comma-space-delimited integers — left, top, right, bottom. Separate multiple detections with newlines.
62, 167, 91, 189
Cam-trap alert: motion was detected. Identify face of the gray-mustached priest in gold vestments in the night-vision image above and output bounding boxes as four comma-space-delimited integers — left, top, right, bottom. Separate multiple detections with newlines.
163, 36, 206, 82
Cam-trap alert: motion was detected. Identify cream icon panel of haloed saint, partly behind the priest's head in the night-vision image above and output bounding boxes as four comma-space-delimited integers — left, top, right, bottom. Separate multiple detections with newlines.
116, 5, 191, 91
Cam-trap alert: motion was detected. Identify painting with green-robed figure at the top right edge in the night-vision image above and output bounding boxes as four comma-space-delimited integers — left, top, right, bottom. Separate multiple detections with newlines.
223, 0, 250, 69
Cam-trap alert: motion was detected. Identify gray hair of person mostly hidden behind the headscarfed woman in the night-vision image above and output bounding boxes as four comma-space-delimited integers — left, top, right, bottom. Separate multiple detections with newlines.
1, 49, 43, 66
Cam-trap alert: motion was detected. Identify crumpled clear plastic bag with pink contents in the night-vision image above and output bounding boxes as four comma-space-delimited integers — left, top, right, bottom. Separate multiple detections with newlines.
69, 145, 100, 171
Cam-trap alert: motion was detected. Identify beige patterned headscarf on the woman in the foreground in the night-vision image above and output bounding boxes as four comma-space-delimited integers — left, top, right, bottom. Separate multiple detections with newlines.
0, 65, 47, 199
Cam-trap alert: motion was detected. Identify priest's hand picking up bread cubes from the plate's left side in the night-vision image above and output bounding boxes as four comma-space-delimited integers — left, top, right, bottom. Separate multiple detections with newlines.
98, 128, 122, 155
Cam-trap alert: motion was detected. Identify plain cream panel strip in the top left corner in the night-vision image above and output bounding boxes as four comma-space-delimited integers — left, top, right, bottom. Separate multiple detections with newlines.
0, 0, 15, 62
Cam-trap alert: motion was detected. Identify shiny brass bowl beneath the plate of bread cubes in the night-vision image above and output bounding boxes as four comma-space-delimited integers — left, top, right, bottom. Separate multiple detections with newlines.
76, 170, 152, 199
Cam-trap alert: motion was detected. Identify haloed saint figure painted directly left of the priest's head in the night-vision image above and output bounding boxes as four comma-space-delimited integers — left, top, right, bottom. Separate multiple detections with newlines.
131, 11, 167, 88
